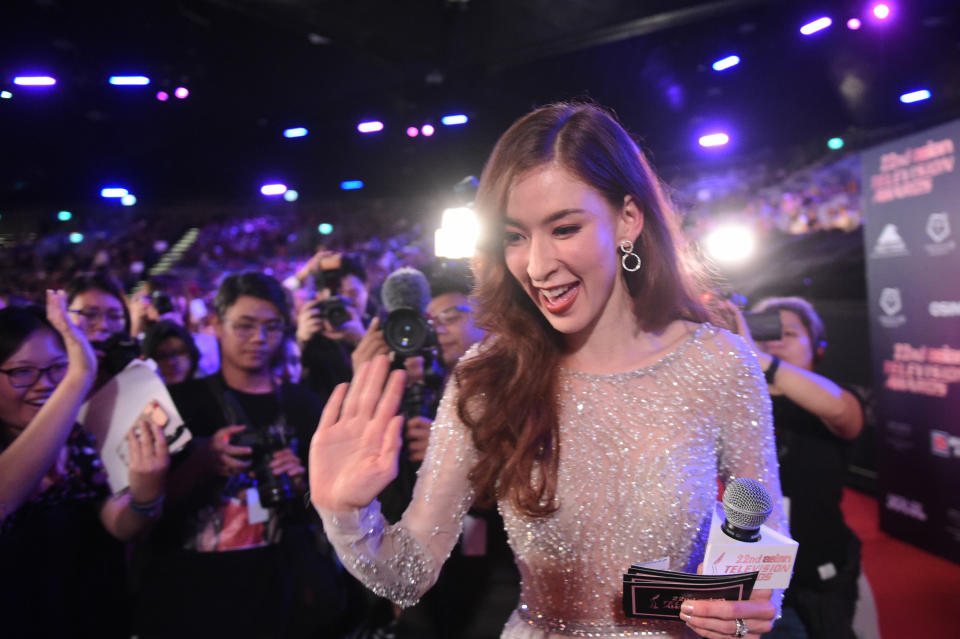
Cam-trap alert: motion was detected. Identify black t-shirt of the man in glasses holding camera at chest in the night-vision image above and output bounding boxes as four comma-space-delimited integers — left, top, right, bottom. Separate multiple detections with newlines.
136, 375, 364, 637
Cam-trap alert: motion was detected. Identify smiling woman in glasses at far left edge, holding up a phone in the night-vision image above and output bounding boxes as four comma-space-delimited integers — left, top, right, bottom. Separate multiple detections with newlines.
0, 292, 169, 637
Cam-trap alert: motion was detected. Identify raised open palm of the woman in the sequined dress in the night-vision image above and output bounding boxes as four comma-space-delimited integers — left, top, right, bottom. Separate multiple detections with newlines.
310, 355, 405, 511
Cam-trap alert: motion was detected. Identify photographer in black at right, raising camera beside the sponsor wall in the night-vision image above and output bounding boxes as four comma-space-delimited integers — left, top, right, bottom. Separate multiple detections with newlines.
731, 297, 864, 639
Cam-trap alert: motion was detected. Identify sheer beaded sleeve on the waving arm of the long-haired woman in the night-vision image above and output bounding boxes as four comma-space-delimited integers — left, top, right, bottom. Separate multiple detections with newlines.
320, 372, 476, 607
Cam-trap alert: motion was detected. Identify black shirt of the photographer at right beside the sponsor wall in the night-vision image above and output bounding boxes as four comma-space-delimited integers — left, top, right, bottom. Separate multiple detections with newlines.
772, 395, 854, 587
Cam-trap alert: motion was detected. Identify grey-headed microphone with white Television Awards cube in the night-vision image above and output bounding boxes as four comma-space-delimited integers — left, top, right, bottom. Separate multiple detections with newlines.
703, 477, 798, 588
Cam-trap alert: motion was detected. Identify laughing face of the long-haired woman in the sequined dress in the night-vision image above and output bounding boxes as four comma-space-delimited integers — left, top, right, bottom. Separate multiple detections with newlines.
504, 164, 643, 336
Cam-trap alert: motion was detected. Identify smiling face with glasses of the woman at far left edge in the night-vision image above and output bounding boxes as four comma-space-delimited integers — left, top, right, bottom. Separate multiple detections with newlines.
0, 328, 67, 439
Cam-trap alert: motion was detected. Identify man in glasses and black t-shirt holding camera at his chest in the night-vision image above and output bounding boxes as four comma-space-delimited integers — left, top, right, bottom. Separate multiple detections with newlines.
131, 273, 360, 637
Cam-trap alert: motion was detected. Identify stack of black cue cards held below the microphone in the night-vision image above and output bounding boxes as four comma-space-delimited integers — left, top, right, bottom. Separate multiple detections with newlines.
623, 565, 759, 619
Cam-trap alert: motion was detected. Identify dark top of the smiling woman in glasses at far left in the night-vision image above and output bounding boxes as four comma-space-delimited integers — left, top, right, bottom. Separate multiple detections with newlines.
0, 426, 130, 639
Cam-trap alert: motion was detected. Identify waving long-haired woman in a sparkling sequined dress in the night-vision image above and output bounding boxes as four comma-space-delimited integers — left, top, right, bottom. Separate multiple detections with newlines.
310, 104, 785, 639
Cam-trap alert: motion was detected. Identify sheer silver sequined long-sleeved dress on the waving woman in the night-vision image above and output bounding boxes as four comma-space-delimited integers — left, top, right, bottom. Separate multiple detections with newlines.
320, 324, 787, 639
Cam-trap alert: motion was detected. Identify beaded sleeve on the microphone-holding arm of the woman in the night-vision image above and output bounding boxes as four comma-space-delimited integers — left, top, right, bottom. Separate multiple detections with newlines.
717, 332, 790, 616
